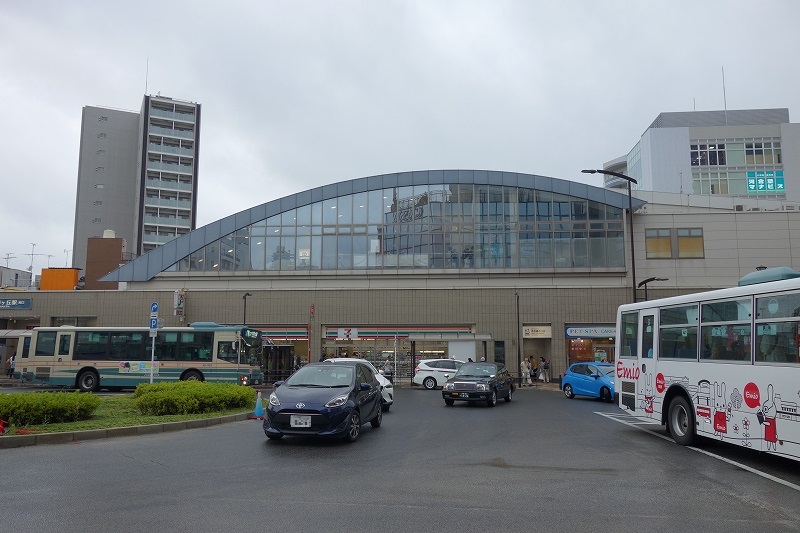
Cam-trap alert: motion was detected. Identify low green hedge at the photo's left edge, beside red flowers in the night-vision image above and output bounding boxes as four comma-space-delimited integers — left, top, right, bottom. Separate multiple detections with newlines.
0, 392, 100, 426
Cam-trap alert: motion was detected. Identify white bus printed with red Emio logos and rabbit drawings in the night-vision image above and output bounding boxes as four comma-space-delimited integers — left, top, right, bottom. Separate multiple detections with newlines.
615, 268, 800, 460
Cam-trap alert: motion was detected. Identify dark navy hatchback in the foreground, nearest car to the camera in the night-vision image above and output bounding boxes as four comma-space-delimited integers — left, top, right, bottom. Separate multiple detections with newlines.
264, 363, 383, 442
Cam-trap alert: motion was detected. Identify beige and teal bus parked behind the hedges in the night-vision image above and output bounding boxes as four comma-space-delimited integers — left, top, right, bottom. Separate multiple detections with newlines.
16, 322, 264, 392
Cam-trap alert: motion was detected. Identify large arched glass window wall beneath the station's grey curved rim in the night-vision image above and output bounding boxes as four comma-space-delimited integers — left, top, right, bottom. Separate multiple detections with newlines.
167, 183, 625, 272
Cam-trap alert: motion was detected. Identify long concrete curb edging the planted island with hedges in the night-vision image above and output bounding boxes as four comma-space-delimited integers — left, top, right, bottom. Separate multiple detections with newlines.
0, 412, 252, 449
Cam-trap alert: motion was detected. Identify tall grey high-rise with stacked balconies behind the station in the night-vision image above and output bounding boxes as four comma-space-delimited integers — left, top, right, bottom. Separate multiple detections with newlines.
72, 95, 200, 270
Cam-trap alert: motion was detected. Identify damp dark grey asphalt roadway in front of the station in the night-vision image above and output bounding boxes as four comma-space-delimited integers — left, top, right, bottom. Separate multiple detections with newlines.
0, 388, 800, 533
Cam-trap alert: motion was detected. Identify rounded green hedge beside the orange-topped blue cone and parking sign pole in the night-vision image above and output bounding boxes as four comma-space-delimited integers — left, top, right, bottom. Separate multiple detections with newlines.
133, 381, 256, 415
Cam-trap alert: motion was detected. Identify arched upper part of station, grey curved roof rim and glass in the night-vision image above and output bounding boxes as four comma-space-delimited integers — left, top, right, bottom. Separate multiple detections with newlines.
102, 170, 645, 281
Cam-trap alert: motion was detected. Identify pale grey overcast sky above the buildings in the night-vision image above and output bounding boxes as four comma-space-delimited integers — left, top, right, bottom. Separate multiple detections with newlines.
0, 0, 800, 274
